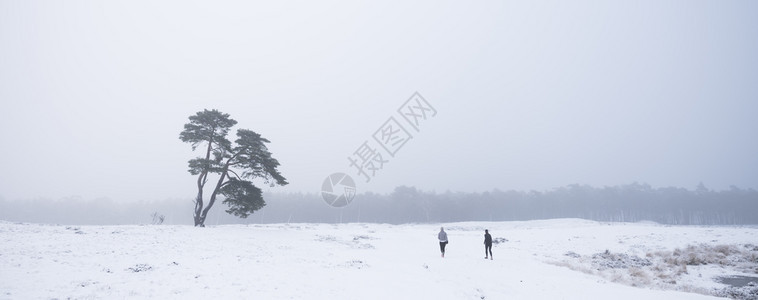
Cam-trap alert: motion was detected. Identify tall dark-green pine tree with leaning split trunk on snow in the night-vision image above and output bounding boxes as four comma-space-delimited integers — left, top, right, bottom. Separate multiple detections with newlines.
179, 109, 287, 227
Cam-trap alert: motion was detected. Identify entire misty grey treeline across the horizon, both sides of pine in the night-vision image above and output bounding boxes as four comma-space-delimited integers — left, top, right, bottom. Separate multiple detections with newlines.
0, 183, 758, 225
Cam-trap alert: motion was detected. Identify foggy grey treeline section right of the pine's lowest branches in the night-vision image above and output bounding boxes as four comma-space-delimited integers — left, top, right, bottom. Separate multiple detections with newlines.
258, 183, 758, 225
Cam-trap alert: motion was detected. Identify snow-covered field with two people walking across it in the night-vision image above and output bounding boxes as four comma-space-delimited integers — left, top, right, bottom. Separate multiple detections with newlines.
0, 219, 758, 299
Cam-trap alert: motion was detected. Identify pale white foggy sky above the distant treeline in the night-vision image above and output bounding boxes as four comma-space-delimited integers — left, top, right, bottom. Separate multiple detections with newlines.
0, 0, 758, 201
